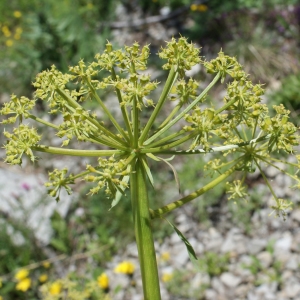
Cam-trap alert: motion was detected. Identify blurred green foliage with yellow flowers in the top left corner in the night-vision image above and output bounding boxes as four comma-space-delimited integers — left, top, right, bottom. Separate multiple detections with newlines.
0, 0, 117, 93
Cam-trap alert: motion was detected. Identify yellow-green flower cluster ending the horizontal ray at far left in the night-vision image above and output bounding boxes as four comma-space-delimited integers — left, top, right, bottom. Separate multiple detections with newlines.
3, 124, 41, 165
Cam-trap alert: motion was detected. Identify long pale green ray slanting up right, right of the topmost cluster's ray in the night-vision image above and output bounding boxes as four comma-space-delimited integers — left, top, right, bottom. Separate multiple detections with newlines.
144, 73, 221, 145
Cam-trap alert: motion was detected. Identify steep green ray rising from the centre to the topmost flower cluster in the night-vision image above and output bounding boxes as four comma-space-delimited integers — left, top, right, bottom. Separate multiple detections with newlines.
140, 66, 178, 144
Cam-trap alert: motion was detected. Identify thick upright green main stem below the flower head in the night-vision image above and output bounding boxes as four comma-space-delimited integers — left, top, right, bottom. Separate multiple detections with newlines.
130, 160, 161, 300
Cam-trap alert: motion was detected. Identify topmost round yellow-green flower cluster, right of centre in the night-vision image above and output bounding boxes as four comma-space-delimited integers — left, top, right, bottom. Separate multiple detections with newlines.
158, 37, 201, 77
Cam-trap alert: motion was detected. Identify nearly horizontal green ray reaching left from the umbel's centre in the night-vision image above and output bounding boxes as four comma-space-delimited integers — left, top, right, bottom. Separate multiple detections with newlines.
31, 145, 124, 157
